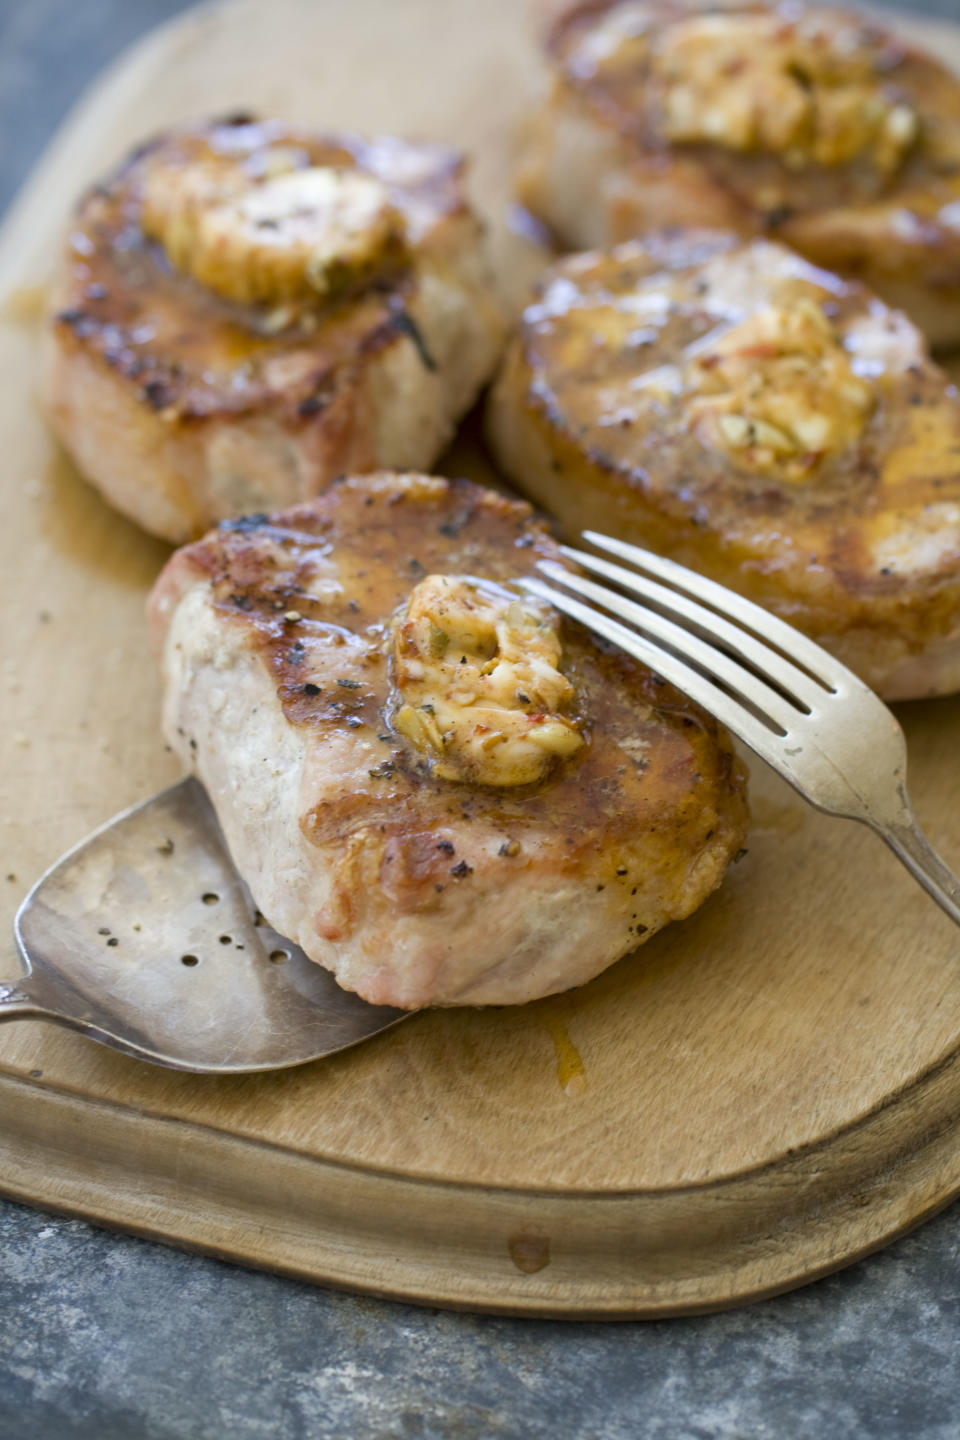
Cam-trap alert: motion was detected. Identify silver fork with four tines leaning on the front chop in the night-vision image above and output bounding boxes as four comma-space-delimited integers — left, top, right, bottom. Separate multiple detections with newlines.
522, 530, 960, 924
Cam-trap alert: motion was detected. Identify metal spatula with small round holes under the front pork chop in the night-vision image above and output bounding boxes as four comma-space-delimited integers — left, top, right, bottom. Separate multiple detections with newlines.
0, 779, 409, 1074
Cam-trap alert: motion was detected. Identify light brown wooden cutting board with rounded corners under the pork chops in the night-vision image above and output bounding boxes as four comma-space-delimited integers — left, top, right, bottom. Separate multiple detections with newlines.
0, 0, 960, 1318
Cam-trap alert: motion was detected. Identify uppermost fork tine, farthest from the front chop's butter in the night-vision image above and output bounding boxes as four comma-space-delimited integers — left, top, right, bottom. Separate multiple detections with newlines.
583, 530, 871, 694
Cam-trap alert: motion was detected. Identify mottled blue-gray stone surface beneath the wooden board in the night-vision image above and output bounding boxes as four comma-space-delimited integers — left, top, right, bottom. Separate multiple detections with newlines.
0, 0, 960, 1440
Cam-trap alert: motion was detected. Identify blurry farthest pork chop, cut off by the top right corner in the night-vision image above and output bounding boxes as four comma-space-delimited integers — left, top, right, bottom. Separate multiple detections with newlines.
518, 0, 960, 346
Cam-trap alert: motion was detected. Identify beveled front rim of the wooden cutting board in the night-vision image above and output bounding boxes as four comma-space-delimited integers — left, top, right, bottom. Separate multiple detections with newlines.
0, 1056, 960, 1320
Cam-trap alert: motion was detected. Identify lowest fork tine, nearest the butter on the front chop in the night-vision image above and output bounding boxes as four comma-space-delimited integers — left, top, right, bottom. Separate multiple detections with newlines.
520, 576, 782, 768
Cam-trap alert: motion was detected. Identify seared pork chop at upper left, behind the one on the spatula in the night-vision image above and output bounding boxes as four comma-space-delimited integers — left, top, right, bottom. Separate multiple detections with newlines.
43, 117, 502, 541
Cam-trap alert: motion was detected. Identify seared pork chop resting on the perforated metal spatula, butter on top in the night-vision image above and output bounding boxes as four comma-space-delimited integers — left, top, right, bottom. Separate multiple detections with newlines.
151, 474, 747, 1008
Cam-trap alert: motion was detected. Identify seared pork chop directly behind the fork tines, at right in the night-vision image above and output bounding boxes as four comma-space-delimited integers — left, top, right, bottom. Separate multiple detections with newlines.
489, 230, 960, 698
